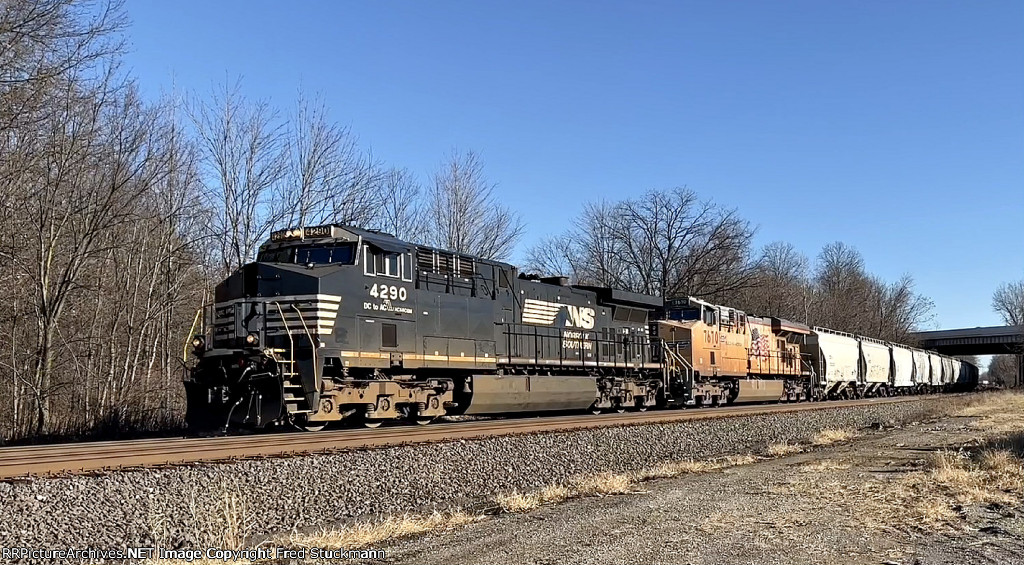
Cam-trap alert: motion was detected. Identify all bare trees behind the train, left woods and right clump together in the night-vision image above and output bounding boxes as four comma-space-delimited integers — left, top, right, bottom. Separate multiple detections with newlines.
0, 0, 1011, 442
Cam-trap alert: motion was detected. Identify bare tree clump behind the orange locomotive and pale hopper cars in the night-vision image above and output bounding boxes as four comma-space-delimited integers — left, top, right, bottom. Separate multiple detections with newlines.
527, 187, 933, 343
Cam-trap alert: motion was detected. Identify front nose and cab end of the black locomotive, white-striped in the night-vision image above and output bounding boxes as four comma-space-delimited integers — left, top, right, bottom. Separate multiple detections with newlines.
184, 226, 385, 429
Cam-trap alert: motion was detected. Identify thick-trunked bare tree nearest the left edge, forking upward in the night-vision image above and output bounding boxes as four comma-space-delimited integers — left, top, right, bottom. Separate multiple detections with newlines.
11, 76, 164, 434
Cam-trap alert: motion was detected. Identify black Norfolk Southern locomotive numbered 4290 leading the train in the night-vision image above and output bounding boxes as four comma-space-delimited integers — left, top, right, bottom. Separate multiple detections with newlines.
185, 225, 673, 430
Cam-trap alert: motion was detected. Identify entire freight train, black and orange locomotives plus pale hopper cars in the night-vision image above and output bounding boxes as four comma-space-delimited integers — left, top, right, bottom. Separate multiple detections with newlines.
184, 225, 977, 431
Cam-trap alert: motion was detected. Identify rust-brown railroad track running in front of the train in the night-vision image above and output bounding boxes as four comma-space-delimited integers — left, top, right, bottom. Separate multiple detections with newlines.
0, 396, 927, 480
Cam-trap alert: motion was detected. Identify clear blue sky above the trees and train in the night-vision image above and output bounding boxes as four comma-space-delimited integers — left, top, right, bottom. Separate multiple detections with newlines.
121, 0, 1024, 328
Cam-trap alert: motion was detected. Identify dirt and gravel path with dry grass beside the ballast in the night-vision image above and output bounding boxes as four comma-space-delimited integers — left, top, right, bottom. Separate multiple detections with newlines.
368, 411, 1024, 565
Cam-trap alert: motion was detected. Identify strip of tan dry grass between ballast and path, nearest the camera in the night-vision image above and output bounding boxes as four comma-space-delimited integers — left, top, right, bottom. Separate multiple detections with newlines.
279, 510, 484, 550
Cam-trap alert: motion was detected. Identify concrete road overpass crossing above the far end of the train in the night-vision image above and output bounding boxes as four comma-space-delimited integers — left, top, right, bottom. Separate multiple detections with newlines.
911, 325, 1024, 386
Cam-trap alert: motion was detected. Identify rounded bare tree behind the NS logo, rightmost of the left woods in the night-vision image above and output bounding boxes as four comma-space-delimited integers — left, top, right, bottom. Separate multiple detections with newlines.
426, 147, 524, 259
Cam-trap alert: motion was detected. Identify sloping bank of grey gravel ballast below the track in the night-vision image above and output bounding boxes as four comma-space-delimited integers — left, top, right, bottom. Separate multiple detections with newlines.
0, 398, 945, 560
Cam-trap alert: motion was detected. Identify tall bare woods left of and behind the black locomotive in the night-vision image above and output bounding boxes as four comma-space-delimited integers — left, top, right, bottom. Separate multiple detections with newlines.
0, 0, 523, 442
